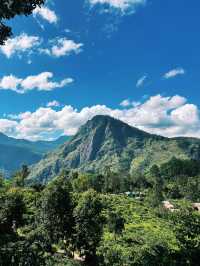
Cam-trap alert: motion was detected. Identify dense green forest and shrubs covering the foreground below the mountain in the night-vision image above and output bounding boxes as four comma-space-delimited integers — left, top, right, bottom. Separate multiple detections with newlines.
0, 157, 200, 266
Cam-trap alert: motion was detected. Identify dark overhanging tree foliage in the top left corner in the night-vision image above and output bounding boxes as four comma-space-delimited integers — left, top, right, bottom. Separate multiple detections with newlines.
0, 0, 45, 45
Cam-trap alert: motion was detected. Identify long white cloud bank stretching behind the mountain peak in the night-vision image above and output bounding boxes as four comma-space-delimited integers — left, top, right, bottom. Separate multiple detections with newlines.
0, 95, 200, 140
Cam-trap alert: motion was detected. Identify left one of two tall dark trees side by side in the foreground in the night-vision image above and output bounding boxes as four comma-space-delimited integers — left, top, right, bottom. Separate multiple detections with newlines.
39, 176, 73, 246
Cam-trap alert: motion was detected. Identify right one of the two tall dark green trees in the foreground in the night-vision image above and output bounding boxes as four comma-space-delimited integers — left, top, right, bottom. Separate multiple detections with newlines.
74, 190, 103, 261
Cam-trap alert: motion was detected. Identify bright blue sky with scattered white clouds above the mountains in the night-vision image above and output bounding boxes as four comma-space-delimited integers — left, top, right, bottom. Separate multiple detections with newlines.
0, 0, 200, 141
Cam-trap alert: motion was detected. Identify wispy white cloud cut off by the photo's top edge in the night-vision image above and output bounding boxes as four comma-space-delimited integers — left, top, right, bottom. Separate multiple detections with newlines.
88, 0, 146, 12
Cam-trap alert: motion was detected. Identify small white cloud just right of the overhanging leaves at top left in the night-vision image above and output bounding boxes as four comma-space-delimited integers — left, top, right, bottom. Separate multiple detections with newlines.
33, 6, 58, 24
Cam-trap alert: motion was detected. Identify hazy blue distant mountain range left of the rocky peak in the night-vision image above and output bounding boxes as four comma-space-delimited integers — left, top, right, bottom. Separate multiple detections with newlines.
0, 133, 67, 177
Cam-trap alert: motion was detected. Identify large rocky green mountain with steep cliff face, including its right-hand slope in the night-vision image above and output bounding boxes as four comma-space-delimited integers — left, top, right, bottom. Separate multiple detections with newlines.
29, 115, 200, 183
